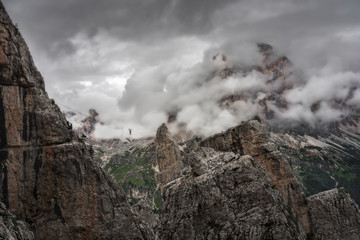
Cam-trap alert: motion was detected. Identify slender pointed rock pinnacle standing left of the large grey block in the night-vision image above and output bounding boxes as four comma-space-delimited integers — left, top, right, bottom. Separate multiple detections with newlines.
155, 123, 181, 186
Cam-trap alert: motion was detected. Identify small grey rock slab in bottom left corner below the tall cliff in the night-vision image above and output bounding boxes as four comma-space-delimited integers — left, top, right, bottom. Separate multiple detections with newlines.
0, 203, 34, 240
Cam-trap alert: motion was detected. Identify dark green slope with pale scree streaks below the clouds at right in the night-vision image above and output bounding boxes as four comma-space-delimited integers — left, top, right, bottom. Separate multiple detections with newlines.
270, 119, 360, 204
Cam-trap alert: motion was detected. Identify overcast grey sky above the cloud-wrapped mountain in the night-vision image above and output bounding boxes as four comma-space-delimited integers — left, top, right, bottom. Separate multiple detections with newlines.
3, 0, 360, 136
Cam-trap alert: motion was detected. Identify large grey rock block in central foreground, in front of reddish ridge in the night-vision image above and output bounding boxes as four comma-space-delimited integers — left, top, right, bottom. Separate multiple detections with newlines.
160, 152, 306, 240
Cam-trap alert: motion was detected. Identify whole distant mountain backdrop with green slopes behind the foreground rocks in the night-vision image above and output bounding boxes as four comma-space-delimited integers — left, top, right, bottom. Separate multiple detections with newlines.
63, 41, 360, 232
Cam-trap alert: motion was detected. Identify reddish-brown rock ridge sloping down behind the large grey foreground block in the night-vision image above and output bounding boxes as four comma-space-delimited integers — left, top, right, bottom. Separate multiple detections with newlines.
200, 120, 312, 234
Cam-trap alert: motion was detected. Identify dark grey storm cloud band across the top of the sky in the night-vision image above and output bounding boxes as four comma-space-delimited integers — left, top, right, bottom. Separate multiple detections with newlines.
4, 0, 360, 67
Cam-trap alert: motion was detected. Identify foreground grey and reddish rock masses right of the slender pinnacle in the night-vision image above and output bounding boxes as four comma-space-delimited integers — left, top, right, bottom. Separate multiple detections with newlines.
157, 121, 360, 239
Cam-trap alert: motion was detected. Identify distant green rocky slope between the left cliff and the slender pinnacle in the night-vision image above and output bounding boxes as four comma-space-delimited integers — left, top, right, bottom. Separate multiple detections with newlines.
65, 109, 161, 213
